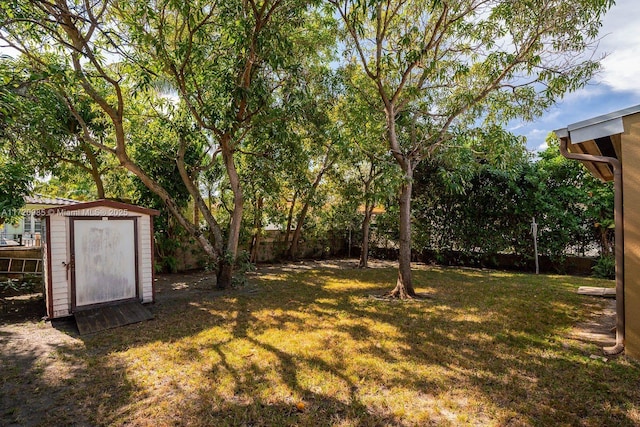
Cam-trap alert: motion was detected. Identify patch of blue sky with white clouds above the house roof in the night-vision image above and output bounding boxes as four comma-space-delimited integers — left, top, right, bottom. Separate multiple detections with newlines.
508, 0, 640, 152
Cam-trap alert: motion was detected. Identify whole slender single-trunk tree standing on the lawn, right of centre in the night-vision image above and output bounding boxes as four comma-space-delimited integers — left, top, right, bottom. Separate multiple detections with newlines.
330, 0, 613, 298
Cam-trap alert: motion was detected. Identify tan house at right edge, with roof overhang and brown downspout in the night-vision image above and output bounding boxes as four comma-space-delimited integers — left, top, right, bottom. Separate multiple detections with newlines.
555, 105, 640, 359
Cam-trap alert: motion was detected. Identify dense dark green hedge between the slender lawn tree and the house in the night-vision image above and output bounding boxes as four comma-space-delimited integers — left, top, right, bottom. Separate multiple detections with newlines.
414, 133, 613, 260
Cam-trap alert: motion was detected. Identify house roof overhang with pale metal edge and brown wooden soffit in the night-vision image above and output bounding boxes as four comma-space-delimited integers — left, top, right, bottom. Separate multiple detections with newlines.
554, 105, 640, 182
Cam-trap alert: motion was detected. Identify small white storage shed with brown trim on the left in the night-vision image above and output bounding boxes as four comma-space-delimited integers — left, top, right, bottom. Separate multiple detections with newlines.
40, 200, 158, 319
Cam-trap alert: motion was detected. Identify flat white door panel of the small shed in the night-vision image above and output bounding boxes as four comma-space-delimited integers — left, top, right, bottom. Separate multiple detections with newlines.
72, 218, 136, 306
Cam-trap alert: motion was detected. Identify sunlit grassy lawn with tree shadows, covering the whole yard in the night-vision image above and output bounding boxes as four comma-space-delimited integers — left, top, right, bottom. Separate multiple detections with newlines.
0, 264, 640, 426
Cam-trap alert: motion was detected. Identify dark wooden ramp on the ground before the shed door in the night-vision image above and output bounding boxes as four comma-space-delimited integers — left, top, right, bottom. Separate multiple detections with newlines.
74, 301, 153, 335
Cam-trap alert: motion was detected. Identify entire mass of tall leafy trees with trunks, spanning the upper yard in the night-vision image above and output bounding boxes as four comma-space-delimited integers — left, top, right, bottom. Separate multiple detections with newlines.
0, 0, 612, 297
